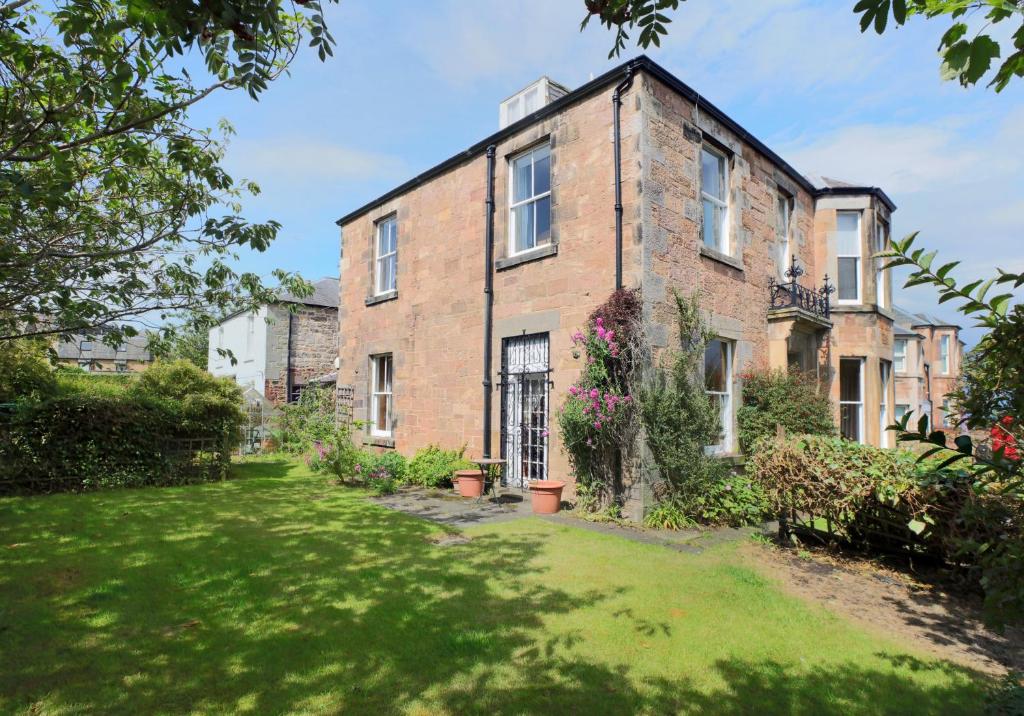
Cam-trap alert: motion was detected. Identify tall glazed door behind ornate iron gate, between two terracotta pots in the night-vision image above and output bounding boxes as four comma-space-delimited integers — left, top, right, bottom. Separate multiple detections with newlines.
501, 333, 551, 488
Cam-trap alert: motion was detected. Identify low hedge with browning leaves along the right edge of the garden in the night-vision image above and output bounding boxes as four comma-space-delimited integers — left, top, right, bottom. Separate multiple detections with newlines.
748, 436, 1024, 625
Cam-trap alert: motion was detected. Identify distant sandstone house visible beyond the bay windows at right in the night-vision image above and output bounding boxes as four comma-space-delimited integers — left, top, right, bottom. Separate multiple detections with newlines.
893, 308, 964, 432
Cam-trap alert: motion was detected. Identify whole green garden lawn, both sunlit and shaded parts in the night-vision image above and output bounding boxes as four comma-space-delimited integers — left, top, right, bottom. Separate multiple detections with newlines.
0, 462, 984, 714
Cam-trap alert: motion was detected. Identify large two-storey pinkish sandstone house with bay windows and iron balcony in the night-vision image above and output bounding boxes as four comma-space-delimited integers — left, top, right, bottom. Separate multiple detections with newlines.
338, 57, 895, 516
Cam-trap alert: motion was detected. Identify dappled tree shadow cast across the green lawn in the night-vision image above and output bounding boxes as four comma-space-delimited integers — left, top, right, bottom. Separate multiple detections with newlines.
0, 465, 991, 714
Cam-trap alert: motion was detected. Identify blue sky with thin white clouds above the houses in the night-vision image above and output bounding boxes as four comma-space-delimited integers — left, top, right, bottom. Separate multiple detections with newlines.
186, 0, 1024, 343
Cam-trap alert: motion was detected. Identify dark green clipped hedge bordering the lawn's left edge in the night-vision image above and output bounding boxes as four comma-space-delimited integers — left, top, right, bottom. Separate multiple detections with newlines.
0, 361, 244, 492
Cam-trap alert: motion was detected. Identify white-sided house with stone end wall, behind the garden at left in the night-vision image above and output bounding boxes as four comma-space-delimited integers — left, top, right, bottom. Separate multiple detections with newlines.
209, 278, 339, 406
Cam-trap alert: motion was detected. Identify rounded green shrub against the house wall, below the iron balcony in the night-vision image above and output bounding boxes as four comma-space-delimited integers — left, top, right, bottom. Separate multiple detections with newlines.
736, 371, 836, 453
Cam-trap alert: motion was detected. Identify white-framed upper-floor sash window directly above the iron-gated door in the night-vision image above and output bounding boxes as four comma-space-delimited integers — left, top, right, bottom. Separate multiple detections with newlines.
509, 144, 551, 255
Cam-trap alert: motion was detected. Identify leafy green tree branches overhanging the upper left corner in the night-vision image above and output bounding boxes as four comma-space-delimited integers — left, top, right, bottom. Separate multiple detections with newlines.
0, 0, 334, 345
